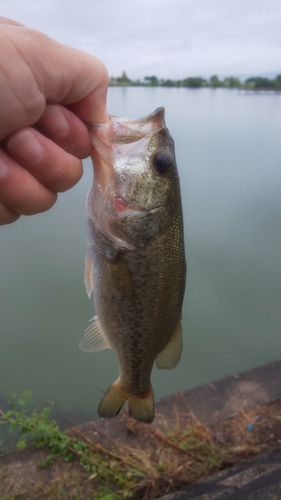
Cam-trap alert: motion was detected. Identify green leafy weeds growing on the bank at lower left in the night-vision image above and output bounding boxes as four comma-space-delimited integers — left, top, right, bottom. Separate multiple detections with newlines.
0, 392, 144, 500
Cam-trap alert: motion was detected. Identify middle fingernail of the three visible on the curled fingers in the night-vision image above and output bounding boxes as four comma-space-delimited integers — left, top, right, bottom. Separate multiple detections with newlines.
7, 130, 44, 163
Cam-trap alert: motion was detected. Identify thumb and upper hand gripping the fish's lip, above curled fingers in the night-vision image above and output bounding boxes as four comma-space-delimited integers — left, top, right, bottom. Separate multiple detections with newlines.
0, 18, 108, 140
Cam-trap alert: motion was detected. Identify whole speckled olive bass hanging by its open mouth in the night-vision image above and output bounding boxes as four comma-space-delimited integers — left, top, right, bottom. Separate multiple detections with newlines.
79, 107, 186, 423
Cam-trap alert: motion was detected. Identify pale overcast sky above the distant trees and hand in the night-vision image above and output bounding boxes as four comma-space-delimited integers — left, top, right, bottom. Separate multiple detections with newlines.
0, 0, 281, 79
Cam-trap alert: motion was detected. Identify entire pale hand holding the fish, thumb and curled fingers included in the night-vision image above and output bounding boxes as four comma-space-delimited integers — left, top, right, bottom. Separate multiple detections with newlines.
0, 17, 108, 225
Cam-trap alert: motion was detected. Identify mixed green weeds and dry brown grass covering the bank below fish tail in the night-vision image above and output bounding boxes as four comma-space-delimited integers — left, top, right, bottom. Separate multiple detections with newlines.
0, 392, 276, 500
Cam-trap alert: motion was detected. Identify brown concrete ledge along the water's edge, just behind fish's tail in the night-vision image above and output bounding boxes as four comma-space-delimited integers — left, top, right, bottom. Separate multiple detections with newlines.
74, 361, 281, 446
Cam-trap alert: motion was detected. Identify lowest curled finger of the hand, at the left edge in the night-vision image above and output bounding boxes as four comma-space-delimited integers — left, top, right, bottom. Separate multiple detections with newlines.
0, 150, 57, 224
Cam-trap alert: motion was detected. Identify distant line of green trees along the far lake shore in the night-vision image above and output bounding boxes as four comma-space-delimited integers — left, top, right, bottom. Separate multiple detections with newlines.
110, 71, 281, 90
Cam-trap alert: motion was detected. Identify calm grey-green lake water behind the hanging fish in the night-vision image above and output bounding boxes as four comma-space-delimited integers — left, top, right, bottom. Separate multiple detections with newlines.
0, 87, 281, 421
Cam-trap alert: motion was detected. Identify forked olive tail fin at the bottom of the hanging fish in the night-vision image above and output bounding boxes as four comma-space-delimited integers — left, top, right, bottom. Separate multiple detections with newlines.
98, 379, 154, 424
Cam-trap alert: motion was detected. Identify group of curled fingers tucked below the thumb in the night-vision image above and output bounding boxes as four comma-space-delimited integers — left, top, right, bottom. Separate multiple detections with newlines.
0, 105, 91, 224
